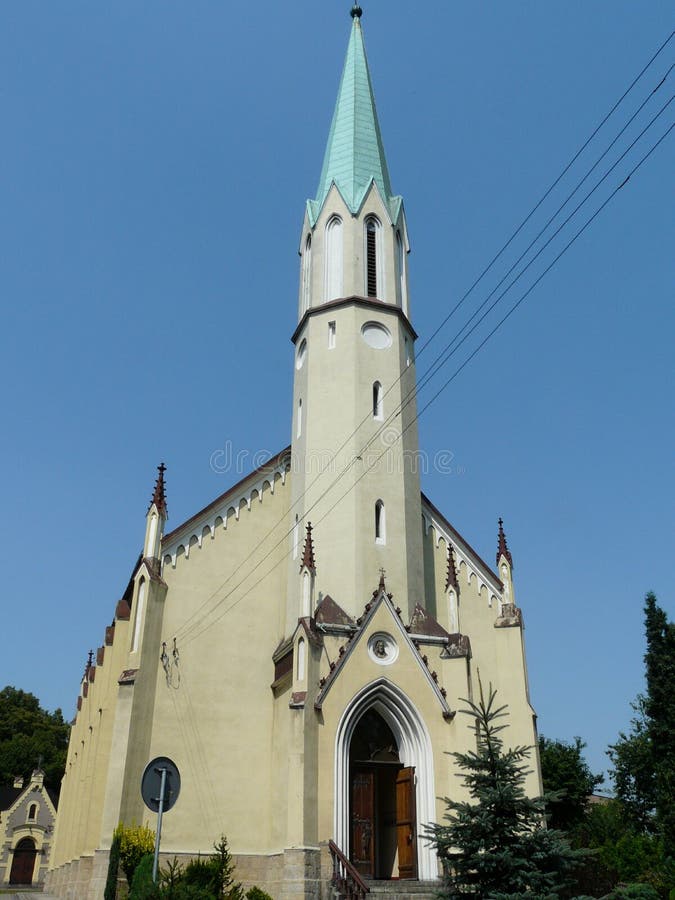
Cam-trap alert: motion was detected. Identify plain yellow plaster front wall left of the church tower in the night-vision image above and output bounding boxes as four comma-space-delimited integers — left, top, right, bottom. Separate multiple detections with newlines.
145, 468, 290, 853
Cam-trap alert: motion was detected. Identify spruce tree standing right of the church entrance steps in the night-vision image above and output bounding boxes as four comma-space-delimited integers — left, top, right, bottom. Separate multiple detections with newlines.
427, 681, 587, 898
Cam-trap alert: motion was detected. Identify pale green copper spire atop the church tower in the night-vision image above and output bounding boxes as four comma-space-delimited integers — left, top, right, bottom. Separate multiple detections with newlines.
308, 11, 400, 224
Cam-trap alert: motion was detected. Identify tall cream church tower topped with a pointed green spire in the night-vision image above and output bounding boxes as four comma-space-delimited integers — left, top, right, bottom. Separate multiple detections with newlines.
287, 6, 424, 629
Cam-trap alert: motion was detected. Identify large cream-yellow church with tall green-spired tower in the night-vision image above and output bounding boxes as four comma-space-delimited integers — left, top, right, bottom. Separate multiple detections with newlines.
47, 7, 540, 900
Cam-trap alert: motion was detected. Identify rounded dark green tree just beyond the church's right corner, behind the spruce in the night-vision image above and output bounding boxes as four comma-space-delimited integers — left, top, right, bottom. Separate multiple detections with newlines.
539, 735, 604, 831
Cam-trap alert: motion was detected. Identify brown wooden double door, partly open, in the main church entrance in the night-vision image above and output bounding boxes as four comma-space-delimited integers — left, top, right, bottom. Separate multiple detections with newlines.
350, 762, 417, 879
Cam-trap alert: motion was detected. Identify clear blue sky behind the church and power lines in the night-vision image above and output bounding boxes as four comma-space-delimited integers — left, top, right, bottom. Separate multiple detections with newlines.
0, 0, 675, 784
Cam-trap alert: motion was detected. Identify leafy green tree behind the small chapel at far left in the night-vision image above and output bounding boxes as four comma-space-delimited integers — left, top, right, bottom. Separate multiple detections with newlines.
0, 685, 70, 791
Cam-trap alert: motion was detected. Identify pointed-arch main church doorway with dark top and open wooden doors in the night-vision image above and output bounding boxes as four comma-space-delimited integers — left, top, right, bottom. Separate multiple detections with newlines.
349, 707, 417, 879
